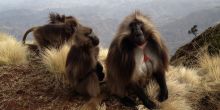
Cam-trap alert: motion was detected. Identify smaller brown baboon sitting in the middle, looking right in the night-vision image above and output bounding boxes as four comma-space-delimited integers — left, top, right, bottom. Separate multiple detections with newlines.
66, 28, 104, 109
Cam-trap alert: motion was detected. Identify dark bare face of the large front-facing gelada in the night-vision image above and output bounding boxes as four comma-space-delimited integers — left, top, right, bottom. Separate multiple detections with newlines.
129, 19, 146, 46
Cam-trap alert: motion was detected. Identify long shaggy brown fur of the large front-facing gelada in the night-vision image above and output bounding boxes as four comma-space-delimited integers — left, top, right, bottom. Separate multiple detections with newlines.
106, 11, 168, 108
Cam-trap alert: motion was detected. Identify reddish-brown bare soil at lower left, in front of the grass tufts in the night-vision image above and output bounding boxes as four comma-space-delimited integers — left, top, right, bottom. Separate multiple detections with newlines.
0, 54, 135, 110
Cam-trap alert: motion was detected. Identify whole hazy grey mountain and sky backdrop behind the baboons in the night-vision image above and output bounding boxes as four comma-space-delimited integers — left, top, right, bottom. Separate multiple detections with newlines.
0, 0, 220, 52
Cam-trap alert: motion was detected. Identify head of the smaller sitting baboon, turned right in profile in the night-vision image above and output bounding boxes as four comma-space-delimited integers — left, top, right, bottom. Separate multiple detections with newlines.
76, 25, 99, 46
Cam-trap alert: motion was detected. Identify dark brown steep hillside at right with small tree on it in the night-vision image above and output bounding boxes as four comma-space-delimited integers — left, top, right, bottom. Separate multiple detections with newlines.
171, 24, 220, 67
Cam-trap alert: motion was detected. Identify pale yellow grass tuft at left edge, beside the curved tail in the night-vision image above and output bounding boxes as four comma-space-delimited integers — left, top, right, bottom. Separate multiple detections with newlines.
0, 33, 28, 65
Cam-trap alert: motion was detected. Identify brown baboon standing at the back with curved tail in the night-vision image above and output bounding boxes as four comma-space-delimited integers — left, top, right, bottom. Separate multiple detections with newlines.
23, 19, 79, 49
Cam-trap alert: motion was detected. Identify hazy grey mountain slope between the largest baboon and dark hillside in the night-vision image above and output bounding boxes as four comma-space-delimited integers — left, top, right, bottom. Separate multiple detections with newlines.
160, 7, 220, 53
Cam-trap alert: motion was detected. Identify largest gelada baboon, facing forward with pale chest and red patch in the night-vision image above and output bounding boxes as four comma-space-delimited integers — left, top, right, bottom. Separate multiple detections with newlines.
106, 11, 168, 109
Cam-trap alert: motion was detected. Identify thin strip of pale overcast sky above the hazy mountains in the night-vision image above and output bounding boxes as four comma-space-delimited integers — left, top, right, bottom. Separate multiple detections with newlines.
0, 0, 220, 11
